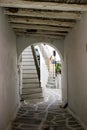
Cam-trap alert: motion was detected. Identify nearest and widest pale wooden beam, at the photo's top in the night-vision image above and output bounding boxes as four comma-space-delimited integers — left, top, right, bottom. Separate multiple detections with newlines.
0, 0, 87, 11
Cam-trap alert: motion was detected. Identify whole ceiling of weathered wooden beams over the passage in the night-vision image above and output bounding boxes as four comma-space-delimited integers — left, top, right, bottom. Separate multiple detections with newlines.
0, 0, 87, 39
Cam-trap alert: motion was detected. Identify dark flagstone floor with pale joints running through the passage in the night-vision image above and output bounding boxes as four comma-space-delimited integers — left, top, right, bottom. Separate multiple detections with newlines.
12, 91, 84, 130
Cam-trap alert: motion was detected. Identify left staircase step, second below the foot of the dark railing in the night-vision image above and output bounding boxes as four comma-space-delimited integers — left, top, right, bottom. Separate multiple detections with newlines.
22, 93, 42, 100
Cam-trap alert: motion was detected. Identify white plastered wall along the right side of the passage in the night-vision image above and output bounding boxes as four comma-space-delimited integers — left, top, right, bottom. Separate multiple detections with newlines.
63, 13, 87, 125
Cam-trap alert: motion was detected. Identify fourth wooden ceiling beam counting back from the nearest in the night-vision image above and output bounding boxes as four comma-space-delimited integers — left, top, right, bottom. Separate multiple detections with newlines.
11, 23, 70, 32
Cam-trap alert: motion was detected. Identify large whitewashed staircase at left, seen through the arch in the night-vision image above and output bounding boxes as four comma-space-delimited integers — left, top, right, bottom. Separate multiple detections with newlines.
21, 47, 43, 103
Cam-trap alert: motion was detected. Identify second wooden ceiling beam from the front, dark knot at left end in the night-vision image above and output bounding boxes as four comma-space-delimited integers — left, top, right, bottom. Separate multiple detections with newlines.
4, 8, 81, 19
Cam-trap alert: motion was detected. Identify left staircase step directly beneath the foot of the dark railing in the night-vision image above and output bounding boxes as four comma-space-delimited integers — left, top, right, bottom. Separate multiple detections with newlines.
22, 88, 42, 94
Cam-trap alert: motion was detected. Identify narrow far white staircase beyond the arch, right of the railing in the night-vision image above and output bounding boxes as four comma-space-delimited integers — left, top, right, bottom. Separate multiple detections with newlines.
39, 44, 56, 88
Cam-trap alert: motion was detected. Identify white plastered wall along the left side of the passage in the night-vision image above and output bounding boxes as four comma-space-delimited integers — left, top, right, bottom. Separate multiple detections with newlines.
0, 8, 19, 130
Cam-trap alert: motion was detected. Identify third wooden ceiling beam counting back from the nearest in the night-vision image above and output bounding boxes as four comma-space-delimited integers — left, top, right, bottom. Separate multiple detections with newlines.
9, 17, 75, 27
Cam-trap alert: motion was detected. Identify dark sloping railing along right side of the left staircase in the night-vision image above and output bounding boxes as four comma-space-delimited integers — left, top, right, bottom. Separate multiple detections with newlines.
31, 45, 40, 83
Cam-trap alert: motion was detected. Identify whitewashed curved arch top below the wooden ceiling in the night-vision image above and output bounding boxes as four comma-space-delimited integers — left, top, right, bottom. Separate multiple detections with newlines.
17, 36, 64, 61
